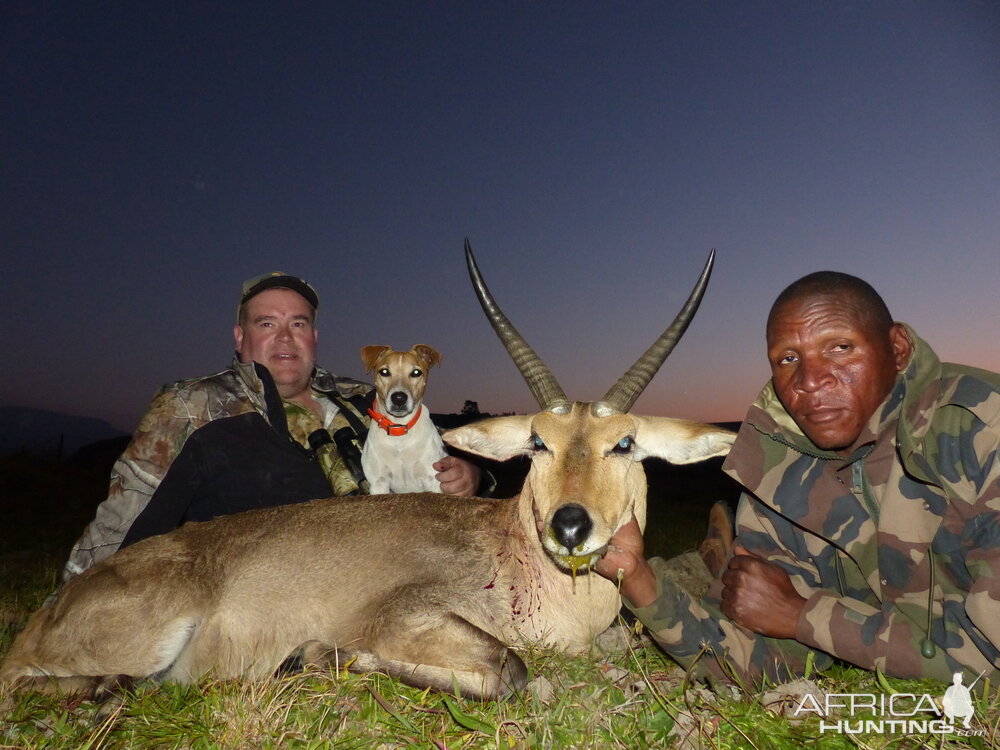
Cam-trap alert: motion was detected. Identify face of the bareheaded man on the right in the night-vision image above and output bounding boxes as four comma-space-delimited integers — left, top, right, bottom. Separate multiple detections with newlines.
767, 295, 912, 452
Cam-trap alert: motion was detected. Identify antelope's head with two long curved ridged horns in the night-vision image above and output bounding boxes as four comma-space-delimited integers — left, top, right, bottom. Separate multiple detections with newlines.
443, 240, 735, 573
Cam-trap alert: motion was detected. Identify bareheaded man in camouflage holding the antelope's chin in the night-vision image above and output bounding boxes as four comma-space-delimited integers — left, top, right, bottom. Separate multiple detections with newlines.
598, 271, 1000, 682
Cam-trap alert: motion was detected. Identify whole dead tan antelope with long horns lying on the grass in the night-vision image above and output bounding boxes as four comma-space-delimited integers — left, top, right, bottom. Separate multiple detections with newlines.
0, 243, 733, 698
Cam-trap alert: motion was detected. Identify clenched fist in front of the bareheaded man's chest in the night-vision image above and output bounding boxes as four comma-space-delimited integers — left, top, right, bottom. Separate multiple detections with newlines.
722, 545, 806, 638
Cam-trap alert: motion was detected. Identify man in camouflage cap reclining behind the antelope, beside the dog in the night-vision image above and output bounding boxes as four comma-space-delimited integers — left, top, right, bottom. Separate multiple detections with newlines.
63, 272, 481, 580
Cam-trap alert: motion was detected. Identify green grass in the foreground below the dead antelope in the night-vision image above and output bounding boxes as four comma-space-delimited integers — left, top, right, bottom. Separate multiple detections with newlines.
7, 642, 1000, 750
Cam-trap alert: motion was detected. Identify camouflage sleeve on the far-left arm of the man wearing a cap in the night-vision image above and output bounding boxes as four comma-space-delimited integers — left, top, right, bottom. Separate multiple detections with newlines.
63, 385, 204, 582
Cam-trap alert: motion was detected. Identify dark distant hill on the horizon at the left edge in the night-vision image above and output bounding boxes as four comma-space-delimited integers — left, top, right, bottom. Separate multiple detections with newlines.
0, 406, 125, 458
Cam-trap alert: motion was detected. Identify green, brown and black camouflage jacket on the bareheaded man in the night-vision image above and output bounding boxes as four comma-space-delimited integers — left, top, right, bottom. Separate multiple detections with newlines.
636, 328, 1000, 681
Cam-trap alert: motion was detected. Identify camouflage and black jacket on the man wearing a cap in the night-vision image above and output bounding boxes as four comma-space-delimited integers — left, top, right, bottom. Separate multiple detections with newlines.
63, 360, 371, 580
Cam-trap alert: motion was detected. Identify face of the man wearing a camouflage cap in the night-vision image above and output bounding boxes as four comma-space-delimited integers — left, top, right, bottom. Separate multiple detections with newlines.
233, 289, 316, 399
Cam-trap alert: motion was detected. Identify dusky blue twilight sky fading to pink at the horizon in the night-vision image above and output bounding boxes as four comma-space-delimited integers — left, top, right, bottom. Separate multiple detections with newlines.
0, 0, 1000, 431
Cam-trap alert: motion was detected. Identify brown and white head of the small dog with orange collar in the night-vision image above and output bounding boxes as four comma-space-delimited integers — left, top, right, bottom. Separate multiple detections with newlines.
361, 344, 441, 419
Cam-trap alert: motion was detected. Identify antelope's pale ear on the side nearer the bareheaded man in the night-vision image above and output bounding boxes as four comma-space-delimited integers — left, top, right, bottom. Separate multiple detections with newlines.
633, 416, 736, 464
